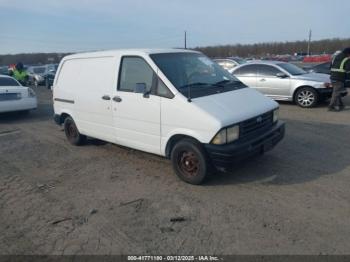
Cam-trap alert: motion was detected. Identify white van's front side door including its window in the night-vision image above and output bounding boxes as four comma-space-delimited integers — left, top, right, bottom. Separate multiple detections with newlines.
112, 56, 161, 154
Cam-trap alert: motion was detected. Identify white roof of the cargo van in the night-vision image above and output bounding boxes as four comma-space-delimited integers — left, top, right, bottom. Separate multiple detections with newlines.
64, 48, 199, 59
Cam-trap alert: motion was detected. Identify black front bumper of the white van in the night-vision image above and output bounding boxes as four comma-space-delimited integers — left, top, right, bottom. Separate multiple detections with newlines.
205, 121, 285, 170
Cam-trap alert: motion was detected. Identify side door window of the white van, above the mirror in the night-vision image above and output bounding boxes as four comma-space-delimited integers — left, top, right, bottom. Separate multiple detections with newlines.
118, 57, 155, 92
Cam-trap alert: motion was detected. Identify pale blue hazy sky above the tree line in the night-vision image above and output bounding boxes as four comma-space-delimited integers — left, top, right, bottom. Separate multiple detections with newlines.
0, 0, 350, 54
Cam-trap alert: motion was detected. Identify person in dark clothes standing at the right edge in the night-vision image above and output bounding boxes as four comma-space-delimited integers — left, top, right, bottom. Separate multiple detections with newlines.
328, 47, 350, 111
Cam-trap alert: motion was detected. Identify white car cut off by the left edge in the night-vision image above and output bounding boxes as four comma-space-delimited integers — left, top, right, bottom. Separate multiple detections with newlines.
0, 75, 37, 113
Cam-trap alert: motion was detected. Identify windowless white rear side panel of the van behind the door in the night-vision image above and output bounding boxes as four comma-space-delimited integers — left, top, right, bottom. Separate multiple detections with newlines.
54, 54, 116, 142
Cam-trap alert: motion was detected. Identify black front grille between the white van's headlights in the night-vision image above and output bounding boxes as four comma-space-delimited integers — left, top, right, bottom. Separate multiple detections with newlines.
239, 111, 273, 138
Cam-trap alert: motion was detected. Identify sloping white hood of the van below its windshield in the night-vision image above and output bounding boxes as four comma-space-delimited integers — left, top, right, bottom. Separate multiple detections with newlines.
192, 88, 278, 127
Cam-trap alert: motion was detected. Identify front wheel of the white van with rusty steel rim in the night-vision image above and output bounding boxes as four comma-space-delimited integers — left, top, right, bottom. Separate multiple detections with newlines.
170, 138, 210, 185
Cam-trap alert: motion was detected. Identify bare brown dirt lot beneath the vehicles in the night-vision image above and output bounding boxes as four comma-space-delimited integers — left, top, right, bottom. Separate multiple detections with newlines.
0, 87, 350, 254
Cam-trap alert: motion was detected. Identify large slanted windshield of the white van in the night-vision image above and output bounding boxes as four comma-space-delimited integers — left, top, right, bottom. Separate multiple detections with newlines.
150, 52, 246, 98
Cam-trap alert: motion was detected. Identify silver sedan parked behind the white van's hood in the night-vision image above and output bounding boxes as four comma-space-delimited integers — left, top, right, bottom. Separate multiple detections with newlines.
232, 61, 347, 108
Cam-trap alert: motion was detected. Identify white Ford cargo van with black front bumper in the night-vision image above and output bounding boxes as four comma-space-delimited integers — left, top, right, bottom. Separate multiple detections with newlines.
53, 49, 284, 184
